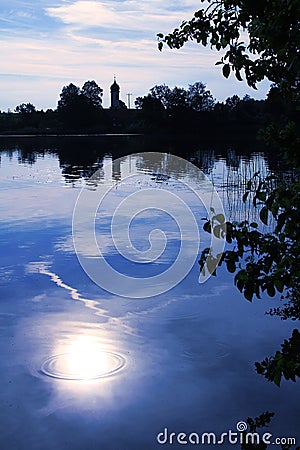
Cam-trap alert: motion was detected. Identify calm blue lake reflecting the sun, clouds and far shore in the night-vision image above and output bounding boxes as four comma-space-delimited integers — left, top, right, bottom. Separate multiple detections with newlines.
0, 136, 300, 450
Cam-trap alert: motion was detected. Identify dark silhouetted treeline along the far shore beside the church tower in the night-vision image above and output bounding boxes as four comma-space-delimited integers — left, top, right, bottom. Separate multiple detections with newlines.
0, 81, 299, 139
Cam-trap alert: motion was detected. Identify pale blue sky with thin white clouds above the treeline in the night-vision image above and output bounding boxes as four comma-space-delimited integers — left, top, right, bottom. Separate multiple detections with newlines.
0, 0, 269, 111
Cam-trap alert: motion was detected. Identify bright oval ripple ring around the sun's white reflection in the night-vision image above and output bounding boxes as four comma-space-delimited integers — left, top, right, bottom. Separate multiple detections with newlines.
41, 351, 126, 380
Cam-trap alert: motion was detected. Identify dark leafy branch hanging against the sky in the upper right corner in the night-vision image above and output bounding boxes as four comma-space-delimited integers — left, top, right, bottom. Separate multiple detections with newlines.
157, 0, 300, 96
